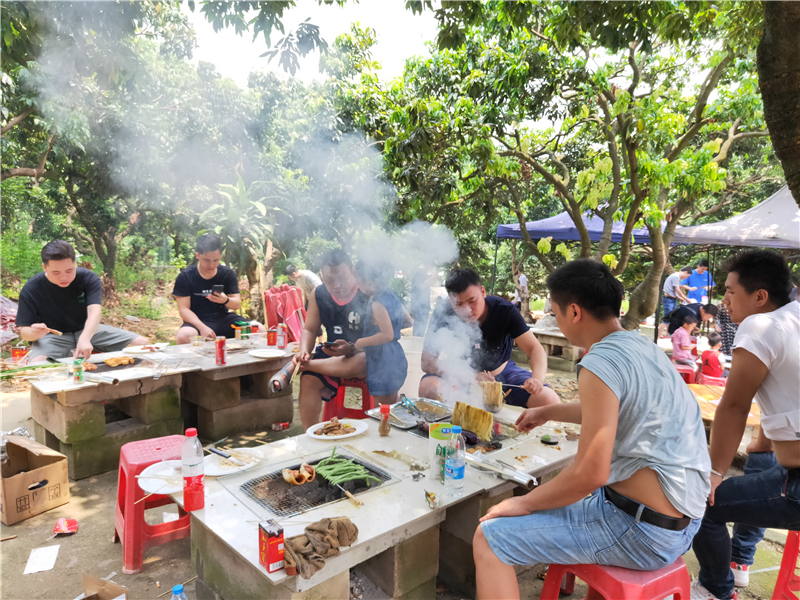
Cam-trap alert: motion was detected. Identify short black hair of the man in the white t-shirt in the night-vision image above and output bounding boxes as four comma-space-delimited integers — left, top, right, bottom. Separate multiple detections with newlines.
721, 250, 792, 307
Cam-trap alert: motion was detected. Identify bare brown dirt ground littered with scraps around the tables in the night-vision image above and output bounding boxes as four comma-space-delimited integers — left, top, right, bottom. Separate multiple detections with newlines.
0, 372, 782, 600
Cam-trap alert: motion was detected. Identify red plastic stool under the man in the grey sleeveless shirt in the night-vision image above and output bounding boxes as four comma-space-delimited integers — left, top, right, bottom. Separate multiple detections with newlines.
539, 558, 691, 600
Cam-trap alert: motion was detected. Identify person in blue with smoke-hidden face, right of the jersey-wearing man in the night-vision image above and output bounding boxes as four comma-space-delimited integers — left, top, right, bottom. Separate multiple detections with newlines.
355, 260, 408, 404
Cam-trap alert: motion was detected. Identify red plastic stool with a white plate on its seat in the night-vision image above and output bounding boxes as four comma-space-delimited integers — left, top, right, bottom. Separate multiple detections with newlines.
114, 435, 190, 574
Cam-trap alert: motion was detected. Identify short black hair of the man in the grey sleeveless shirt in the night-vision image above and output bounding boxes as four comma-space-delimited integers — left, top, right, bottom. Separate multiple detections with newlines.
547, 258, 624, 321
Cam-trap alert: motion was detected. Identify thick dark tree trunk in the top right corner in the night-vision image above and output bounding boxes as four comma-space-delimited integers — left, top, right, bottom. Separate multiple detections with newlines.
757, 2, 800, 205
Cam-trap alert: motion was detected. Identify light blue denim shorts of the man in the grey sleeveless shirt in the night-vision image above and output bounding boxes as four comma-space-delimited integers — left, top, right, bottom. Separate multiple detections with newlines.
481, 488, 700, 571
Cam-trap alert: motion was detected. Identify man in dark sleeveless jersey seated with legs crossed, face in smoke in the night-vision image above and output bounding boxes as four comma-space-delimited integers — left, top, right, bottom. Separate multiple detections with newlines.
293, 250, 369, 428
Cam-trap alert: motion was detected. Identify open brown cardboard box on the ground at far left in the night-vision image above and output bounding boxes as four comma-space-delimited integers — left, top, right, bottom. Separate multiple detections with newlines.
0, 435, 69, 525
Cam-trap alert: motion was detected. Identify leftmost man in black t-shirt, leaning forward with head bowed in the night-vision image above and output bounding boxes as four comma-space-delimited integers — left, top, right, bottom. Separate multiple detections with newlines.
16, 240, 148, 363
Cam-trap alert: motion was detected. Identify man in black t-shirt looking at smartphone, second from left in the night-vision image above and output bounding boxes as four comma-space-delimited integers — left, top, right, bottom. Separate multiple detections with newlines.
172, 233, 242, 344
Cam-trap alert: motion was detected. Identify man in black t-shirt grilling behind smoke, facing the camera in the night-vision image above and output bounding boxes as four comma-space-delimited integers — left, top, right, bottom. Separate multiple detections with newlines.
419, 269, 559, 407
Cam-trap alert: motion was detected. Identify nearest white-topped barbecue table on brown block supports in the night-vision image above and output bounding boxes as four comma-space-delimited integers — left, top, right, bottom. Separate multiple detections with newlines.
173, 408, 577, 600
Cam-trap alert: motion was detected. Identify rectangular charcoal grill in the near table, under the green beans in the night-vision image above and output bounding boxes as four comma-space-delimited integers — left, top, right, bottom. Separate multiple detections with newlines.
218, 447, 400, 519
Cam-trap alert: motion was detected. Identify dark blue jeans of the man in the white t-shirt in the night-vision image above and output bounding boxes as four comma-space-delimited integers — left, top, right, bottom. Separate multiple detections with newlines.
693, 459, 800, 598
